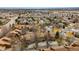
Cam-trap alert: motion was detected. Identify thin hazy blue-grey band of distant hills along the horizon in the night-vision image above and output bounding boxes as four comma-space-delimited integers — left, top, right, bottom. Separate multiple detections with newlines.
0, 7, 79, 10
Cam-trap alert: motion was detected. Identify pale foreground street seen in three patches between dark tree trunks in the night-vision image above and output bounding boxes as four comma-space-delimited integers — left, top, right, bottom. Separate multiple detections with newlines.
26, 41, 58, 50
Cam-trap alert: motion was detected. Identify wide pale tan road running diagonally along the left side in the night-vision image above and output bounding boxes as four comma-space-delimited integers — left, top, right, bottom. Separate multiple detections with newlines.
0, 16, 17, 37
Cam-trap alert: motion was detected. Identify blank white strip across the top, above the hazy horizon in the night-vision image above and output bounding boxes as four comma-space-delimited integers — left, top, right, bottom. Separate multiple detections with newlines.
0, 0, 79, 8
